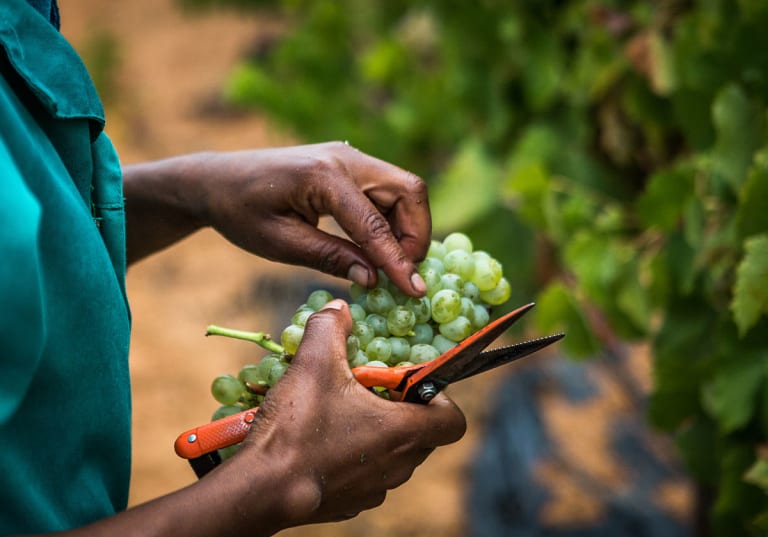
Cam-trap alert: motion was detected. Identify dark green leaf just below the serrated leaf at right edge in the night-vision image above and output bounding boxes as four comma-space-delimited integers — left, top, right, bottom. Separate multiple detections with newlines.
702, 351, 768, 433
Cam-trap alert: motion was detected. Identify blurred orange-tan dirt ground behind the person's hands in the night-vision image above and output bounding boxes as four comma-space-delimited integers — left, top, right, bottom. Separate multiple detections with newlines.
61, 0, 690, 537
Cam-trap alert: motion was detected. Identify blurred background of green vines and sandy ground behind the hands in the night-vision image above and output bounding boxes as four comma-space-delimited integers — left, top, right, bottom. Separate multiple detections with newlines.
61, 0, 768, 537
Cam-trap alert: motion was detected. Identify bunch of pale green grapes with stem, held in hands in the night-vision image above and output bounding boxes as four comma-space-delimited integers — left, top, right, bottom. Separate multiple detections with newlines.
208, 233, 511, 420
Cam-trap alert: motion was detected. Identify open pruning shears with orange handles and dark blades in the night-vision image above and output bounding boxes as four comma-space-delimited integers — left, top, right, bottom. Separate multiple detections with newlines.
174, 303, 565, 478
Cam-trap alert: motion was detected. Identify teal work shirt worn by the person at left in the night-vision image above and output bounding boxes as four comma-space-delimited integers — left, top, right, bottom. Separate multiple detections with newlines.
0, 0, 131, 535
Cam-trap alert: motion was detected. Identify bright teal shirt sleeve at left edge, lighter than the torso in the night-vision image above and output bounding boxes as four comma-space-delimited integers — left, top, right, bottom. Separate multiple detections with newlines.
0, 90, 45, 424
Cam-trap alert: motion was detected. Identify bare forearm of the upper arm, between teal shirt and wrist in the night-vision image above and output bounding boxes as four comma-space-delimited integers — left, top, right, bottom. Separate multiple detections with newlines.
123, 153, 211, 265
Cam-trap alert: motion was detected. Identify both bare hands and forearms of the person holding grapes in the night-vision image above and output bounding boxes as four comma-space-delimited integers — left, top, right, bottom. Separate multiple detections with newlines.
15, 143, 466, 537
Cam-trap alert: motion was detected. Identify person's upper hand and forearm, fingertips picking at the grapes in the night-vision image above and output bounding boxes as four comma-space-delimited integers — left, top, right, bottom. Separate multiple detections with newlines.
126, 142, 431, 296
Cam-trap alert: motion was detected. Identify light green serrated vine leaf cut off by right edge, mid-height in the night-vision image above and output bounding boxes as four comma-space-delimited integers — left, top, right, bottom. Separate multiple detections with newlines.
731, 234, 768, 336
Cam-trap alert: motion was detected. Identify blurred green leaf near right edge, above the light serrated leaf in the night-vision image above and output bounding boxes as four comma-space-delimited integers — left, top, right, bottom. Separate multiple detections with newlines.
712, 84, 765, 191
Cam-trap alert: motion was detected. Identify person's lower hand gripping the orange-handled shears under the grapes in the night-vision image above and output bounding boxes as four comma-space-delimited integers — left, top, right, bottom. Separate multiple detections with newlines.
213, 300, 466, 529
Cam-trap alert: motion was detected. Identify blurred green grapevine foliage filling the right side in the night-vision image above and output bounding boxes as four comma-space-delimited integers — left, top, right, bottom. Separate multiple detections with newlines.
184, 0, 768, 536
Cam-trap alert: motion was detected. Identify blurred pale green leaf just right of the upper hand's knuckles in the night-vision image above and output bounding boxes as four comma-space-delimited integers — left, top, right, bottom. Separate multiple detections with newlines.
429, 139, 499, 233
